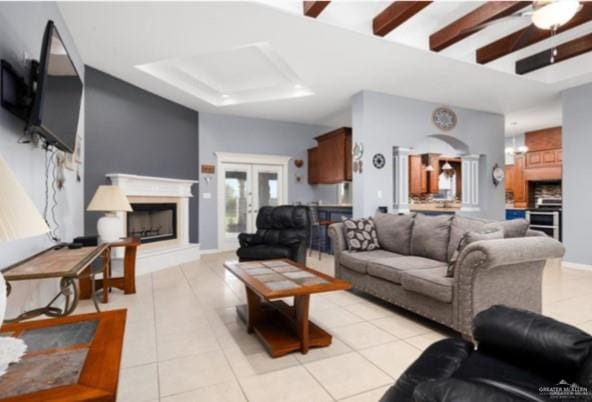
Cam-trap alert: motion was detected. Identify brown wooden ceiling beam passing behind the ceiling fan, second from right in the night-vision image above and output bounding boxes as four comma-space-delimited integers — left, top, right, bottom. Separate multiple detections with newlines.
477, 2, 592, 64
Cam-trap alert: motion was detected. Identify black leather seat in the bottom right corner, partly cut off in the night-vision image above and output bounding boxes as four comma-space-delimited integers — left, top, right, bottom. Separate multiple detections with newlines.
381, 306, 592, 402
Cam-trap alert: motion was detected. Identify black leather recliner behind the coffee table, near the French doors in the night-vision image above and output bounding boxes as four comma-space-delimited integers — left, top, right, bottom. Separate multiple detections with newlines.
236, 205, 310, 264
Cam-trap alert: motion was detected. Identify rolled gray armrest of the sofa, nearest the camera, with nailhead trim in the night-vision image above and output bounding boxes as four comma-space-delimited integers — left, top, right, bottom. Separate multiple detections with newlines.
453, 236, 565, 338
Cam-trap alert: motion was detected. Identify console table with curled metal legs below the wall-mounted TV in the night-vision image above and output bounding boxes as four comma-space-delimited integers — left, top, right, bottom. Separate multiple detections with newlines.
2, 243, 110, 322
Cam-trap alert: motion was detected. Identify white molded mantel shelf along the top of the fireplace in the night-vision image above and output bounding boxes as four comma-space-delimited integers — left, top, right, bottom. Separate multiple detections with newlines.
105, 173, 198, 197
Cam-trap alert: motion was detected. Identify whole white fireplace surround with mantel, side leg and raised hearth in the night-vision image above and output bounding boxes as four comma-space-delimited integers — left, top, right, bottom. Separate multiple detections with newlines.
105, 173, 199, 274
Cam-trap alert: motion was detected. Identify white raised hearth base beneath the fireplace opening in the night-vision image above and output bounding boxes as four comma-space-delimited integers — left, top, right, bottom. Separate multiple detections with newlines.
112, 243, 201, 276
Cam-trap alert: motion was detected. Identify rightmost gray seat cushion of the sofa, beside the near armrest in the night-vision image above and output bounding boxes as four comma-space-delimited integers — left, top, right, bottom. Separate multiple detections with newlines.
401, 267, 454, 303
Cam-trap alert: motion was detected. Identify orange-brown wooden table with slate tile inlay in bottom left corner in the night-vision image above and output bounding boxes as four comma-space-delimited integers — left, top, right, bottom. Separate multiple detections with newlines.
0, 310, 126, 402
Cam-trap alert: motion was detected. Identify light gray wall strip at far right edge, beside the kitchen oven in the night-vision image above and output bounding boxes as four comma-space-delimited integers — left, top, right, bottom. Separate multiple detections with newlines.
562, 84, 592, 265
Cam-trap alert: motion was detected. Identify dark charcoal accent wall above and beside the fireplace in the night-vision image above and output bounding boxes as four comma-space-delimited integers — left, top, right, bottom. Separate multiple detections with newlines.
84, 66, 199, 243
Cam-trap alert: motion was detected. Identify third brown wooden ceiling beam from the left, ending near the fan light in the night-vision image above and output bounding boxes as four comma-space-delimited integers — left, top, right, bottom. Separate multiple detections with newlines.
430, 1, 531, 52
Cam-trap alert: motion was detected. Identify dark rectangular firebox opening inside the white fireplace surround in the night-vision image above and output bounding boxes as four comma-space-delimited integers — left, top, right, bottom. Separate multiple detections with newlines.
127, 203, 177, 243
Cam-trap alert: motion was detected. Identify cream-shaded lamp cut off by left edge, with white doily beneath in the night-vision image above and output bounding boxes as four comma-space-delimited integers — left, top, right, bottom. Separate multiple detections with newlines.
0, 156, 49, 375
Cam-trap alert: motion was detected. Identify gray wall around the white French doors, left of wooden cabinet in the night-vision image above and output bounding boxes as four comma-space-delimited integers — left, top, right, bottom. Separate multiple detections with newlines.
199, 113, 337, 250
